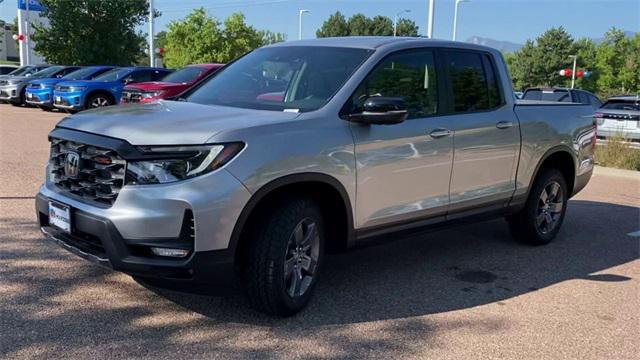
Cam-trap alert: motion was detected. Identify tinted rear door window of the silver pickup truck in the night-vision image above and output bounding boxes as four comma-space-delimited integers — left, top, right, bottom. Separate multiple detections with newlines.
447, 51, 502, 113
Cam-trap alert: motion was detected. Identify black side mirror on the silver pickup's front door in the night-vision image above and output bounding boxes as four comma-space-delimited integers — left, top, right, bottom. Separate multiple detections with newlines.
347, 96, 408, 125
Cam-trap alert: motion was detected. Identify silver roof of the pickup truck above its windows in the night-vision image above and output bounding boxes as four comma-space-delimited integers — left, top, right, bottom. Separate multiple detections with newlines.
269, 36, 495, 50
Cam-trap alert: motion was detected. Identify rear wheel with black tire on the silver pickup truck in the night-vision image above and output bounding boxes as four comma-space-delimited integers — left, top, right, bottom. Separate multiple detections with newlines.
507, 169, 569, 245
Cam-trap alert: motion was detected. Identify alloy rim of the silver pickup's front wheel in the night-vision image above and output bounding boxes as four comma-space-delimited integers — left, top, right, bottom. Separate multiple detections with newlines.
284, 218, 320, 298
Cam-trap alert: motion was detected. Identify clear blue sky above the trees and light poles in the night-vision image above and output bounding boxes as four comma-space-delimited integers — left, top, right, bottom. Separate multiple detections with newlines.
0, 0, 640, 43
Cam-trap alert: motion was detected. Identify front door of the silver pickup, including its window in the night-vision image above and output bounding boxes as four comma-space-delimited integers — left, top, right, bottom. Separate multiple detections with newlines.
345, 49, 453, 228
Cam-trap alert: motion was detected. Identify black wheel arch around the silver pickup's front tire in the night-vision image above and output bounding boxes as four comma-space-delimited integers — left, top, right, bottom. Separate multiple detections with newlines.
229, 173, 354, 260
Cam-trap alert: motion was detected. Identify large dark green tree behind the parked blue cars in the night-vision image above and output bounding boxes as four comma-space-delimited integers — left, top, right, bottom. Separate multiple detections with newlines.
33, 0, 149, 65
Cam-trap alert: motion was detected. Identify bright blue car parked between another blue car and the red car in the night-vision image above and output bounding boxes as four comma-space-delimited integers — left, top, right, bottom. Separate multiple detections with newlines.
53, 67, 171, 112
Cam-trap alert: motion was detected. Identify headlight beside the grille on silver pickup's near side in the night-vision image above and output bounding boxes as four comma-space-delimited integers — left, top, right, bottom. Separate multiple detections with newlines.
127, 143, 244, 185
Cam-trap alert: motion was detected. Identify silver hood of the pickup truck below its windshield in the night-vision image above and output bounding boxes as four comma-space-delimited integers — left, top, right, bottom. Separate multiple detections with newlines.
57, 101, 299, 145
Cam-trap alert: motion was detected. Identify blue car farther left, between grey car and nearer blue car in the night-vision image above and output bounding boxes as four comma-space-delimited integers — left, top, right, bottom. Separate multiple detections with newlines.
25, 66, 114, 110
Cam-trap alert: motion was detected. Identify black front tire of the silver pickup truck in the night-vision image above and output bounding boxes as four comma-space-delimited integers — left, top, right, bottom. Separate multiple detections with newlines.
244, 198, 324, 316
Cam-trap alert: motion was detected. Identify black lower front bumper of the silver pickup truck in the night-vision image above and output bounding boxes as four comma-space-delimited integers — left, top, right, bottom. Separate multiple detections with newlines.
36, 194, 236, 286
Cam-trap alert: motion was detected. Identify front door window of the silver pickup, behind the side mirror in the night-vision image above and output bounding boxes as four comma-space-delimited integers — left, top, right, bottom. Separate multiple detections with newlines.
350, 50, 438, 119
